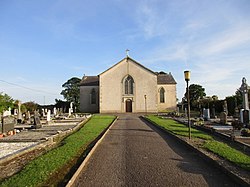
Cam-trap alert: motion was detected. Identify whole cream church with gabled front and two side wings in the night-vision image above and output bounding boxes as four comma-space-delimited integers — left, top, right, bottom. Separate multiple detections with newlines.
80, 56, 176, 113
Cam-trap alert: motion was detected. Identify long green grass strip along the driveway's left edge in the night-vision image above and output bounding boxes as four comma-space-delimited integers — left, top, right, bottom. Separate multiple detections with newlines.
0, 115, 115, 187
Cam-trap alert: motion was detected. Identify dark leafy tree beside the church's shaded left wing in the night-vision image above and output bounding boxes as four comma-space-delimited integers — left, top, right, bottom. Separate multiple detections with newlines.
61, 77, 81, 111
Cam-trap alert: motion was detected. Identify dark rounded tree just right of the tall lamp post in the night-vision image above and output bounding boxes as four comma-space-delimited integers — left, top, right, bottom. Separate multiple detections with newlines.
185, 84, 206, 109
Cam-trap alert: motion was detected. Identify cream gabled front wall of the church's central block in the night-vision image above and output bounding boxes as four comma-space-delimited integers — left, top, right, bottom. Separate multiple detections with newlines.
99, 59, 157, 113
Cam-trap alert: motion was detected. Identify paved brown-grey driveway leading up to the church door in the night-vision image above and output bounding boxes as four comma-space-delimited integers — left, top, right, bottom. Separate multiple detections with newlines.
73, 115, 236, 186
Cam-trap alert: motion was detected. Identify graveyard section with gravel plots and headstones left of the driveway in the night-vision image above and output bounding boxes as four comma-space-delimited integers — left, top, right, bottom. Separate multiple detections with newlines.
0, 103, 91, 183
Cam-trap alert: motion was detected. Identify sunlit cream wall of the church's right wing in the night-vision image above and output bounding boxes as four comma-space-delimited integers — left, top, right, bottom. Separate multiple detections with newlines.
157, 84, 176, 112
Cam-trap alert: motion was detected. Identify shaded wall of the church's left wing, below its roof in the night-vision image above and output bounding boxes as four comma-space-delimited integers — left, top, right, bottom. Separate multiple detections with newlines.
80, 86, 99, 113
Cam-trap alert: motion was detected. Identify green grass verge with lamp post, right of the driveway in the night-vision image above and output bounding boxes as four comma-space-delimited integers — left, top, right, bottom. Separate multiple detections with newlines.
146, 115, 250, 171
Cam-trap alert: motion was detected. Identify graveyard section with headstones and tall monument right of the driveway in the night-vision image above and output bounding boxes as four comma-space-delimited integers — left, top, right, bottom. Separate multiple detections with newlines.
175, 78, 250, 145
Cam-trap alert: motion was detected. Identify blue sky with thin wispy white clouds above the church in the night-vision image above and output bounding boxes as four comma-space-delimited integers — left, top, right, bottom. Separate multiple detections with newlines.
0, 0, 250, 105
